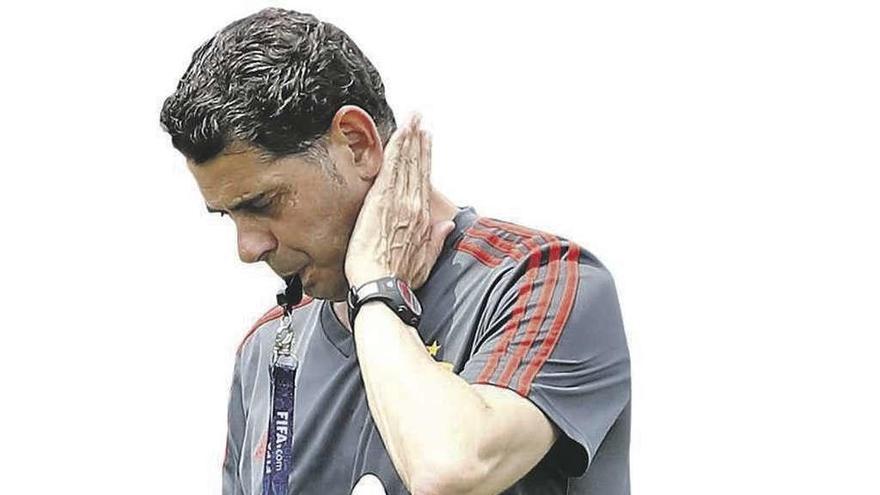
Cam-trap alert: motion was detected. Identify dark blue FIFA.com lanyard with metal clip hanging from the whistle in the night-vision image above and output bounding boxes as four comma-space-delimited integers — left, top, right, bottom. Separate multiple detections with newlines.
263, 314, 297, 495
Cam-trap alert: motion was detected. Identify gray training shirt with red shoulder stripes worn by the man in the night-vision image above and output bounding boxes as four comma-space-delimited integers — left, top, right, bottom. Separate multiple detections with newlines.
223, 207, 630, 495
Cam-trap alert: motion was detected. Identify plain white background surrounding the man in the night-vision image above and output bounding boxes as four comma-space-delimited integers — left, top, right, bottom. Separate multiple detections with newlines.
0, 0, 880, 494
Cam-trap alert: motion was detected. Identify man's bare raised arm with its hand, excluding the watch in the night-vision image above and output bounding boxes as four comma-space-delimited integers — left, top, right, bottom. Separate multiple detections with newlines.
345, 117, 556, 495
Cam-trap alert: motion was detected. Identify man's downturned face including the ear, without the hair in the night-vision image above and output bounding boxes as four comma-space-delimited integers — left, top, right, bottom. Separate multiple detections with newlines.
188, 109, 382, 301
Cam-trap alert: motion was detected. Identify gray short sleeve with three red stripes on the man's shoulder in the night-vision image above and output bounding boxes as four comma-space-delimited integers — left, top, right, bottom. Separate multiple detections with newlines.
460, 240, 630, 477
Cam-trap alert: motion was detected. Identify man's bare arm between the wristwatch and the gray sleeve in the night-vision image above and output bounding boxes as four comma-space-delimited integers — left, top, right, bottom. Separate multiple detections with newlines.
355, 302, 557, 495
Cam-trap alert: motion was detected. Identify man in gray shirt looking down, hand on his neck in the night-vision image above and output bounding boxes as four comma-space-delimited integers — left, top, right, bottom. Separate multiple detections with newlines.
161, 9, 630, 495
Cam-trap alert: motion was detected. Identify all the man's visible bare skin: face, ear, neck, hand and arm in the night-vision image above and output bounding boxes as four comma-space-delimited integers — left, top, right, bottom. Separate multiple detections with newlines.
188, 106, 558, 495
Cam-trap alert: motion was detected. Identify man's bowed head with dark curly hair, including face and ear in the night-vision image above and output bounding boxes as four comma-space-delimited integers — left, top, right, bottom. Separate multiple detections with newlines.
161, 9, 395, 300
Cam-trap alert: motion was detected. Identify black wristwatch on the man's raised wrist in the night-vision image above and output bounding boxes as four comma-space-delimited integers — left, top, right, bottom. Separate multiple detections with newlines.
348, 277, 422, 332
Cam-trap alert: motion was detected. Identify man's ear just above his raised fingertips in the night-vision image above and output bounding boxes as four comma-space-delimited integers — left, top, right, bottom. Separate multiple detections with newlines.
330, 105, 383, 178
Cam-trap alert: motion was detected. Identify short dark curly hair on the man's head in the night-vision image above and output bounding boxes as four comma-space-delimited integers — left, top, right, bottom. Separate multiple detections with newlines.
160, 8, 396, 164
